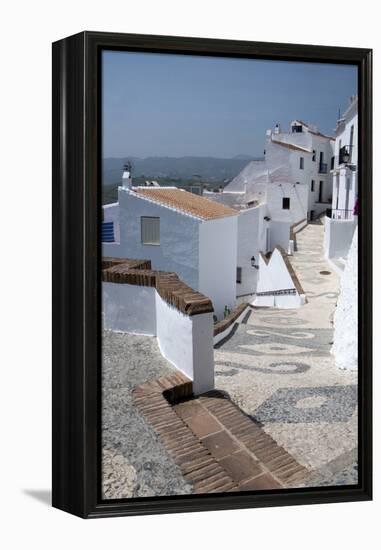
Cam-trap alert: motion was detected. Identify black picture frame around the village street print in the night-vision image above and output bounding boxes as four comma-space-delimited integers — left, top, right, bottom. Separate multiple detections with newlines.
52, 32, 372, 518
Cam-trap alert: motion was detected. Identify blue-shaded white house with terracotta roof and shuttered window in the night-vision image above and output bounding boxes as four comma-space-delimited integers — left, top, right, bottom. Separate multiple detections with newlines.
102, 173, 238, 318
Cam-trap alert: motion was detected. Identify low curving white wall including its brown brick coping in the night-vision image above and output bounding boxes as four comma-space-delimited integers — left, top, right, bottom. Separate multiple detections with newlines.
102, 259, 214, 394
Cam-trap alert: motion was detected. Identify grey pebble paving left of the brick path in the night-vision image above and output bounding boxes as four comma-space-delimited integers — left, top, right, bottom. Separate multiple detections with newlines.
102, 330, 192, 498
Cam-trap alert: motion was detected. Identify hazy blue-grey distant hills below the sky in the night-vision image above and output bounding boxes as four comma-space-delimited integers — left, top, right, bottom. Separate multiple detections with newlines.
103, 155, 258, 186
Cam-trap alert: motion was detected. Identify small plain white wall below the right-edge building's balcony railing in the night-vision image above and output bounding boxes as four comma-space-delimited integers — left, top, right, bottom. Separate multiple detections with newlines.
324, 216, 357, 259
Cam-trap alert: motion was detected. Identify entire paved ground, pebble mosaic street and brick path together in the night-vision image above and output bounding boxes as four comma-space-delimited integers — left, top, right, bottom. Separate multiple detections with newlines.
103, 224, 358, 498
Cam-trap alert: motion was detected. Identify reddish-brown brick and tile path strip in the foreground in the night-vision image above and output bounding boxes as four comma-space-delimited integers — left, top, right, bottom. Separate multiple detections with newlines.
134, 373, 308, 493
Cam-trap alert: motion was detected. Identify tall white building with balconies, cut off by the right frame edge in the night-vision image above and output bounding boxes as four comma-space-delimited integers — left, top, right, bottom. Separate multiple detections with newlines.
324, 96, 358, 268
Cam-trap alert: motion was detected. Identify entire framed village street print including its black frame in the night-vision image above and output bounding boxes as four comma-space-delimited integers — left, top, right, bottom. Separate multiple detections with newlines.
53, 32, 372, 517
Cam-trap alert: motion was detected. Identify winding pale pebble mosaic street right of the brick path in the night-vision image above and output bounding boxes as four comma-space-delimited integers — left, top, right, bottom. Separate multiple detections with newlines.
215, 222, 357, 485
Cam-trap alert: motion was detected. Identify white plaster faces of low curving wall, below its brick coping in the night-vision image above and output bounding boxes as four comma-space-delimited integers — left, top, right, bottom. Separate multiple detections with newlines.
102, 282, 214, 394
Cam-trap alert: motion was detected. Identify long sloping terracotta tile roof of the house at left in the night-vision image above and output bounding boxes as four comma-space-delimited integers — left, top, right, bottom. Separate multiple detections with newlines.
132, 187, 238, 220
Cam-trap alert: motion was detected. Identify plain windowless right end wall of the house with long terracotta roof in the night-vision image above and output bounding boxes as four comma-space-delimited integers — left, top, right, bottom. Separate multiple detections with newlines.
197, 216, 238, 319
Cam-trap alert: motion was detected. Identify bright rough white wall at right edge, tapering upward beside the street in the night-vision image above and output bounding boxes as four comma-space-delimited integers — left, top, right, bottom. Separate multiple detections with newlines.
332, 228, 358, 370
